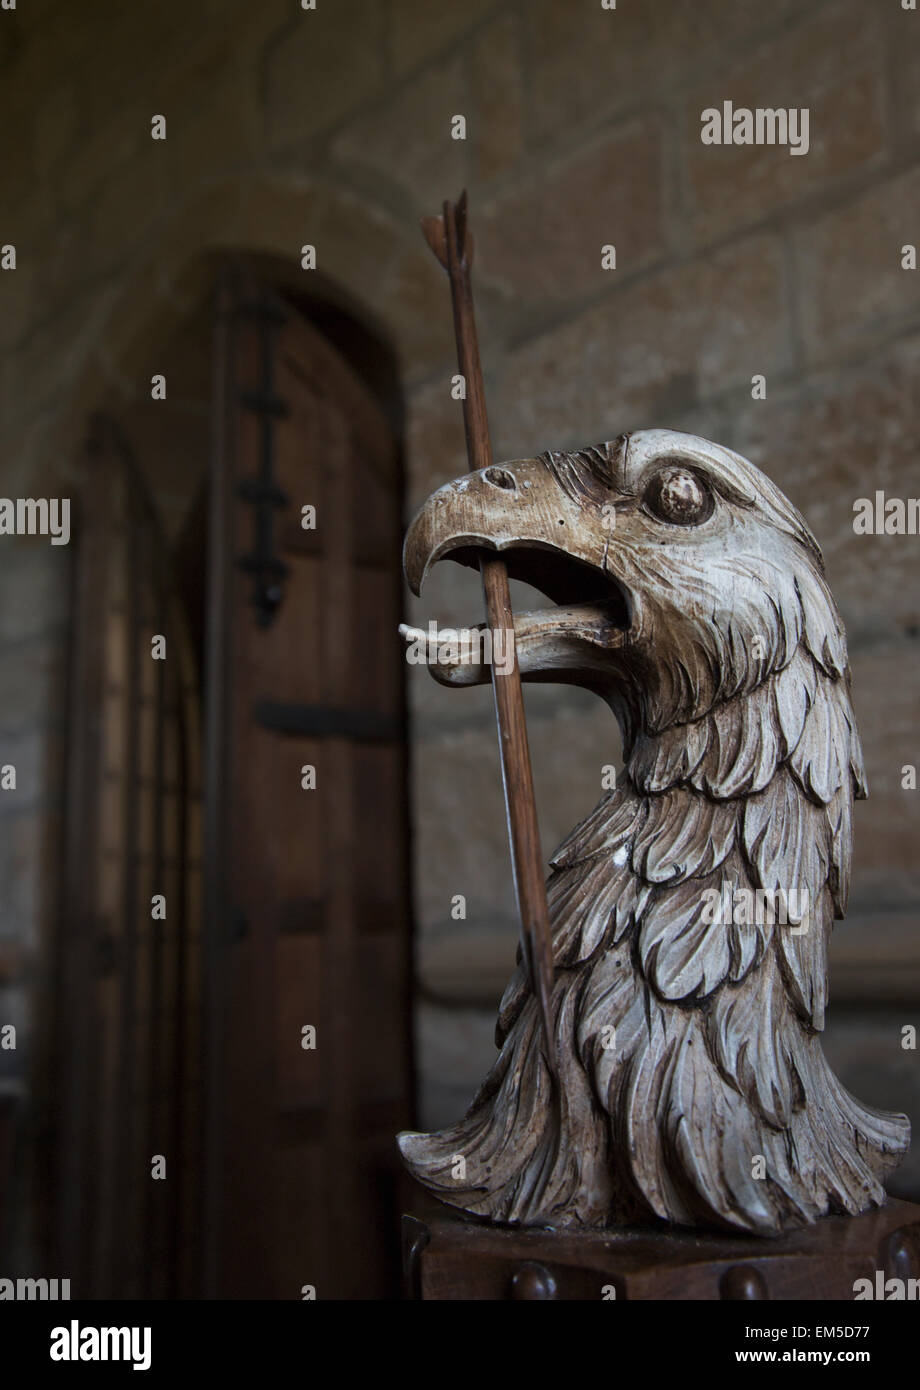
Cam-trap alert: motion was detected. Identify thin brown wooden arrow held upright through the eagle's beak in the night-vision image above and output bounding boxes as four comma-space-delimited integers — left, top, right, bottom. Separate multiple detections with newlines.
421, 189, 559, 1079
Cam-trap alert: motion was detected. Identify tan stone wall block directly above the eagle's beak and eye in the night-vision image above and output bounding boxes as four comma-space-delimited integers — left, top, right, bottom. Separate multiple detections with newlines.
492, 235, 789, 457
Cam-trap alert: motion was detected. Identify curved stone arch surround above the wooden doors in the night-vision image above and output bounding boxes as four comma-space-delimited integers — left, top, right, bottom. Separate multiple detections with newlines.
33, 172, 453, 505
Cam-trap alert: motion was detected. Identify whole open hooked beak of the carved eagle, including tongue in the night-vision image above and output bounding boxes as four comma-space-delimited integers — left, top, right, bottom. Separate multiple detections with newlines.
402, 459, 631, 685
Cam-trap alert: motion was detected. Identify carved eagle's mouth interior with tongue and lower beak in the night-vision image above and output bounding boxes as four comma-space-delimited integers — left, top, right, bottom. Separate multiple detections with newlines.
400, 542, 632, 685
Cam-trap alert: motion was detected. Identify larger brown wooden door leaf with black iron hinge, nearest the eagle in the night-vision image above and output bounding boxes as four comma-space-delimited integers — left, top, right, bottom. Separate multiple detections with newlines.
204, 278, 411, 1298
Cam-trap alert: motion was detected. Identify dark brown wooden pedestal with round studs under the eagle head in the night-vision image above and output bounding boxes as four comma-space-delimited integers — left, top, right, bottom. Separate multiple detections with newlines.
403, 1201, 920, 1301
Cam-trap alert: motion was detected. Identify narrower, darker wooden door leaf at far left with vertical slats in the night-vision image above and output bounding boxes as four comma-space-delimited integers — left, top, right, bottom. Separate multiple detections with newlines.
50, 417, 202, 1298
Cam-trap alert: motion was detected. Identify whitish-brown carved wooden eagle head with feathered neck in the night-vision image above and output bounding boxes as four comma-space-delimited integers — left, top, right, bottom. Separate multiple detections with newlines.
399, 430, 910, 1236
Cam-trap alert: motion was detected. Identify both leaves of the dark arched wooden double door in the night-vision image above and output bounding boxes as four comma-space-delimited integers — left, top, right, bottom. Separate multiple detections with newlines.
57, 275, 413, 1300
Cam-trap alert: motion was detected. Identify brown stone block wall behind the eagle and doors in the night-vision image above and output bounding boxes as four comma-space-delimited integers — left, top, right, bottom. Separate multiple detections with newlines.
0, 0, 920, 1212
